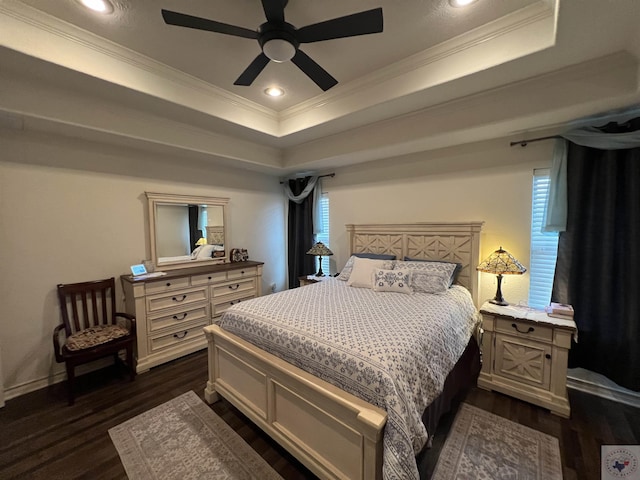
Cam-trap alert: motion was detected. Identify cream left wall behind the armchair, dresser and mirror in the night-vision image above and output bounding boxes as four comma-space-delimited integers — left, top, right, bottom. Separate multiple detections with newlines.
0, 130, 286, 398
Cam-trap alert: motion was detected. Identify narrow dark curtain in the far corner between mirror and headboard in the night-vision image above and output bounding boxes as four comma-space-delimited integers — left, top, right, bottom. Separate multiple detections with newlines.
288, 177, 315, 288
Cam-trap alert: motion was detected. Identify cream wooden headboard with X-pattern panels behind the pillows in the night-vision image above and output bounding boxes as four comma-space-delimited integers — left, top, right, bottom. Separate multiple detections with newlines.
346, 222, 484, 305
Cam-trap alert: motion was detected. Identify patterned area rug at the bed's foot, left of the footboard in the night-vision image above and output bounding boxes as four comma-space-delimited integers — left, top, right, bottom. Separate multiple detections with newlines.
109, 391, 282, 480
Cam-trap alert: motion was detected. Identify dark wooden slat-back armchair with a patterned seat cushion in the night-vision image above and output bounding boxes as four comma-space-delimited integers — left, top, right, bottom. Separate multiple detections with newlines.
53, 277, 136, 405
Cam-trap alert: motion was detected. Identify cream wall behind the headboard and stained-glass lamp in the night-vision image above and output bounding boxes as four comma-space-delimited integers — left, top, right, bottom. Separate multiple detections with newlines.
323, 139, 552, 303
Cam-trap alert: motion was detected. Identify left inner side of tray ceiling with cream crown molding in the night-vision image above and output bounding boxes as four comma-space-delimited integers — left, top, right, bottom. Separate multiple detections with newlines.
0, 0, 278, 135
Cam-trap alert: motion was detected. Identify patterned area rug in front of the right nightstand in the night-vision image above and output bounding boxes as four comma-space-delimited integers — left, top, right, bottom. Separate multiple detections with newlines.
431, 403, 562, 480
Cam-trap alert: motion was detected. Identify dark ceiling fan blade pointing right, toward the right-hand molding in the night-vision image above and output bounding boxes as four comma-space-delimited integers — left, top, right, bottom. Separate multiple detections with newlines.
296, 7, 383, 43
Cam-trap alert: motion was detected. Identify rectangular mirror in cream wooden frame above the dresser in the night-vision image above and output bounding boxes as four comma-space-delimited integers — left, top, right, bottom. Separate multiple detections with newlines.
145, 192, 229, 270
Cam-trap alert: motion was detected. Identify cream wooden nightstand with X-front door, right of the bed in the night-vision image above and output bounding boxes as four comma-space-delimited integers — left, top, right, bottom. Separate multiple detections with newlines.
478, 302, 577, 418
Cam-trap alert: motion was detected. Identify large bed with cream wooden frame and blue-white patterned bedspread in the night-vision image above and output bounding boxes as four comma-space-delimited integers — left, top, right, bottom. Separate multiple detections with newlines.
205, 222, 481, 479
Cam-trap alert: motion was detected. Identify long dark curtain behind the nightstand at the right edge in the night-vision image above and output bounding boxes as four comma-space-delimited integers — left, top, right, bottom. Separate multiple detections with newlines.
552, 137, 640, 391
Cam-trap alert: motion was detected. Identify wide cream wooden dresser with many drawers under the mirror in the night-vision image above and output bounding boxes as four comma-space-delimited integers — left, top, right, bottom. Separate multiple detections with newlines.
120, 261, 263, 373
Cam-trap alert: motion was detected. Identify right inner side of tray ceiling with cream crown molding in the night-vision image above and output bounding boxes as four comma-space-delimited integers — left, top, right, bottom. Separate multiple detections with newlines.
279, 1, 557, 136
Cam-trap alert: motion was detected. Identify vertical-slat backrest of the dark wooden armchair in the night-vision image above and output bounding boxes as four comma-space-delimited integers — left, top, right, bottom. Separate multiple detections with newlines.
58, 277, 116, 336
